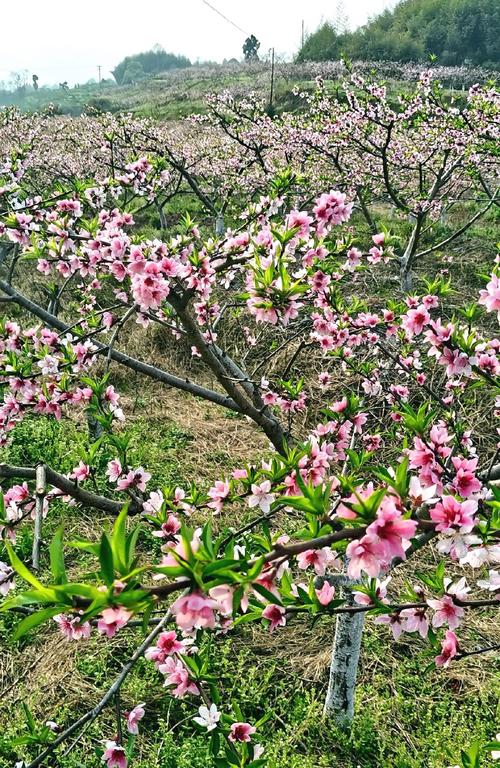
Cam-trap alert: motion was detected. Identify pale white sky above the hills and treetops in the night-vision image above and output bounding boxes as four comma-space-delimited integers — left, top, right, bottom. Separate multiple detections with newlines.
0, 0, 394, 85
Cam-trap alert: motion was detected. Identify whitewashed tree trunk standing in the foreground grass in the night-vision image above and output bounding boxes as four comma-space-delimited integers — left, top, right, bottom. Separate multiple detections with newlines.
324, 585, 365, 727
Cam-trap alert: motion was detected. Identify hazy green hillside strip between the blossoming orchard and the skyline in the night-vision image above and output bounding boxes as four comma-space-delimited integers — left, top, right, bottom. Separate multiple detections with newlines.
0, 56, 495, 120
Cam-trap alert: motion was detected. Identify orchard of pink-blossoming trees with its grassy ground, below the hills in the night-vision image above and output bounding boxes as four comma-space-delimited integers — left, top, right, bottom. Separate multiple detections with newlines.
0, 64, 500, 768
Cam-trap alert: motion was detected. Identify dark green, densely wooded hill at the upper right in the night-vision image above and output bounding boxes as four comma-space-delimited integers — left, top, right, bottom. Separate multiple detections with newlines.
297, 0, 500, 69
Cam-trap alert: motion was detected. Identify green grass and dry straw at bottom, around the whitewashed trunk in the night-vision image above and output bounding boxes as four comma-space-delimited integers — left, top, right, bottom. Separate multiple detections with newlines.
0, 588, 500, 768
